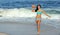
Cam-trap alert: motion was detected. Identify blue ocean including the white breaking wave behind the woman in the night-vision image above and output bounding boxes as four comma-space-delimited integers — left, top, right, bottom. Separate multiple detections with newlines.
0, 1, 60, 25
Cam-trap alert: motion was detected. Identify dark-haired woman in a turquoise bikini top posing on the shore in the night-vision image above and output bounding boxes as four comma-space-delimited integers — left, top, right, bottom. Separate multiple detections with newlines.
32, 4, 50, 34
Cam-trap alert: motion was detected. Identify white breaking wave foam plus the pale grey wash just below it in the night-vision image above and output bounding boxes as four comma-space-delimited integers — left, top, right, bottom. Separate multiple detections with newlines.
0, 8, 60, 28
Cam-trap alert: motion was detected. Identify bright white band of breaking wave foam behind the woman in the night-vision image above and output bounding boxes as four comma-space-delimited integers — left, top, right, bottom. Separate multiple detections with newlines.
0, 8, 60, 19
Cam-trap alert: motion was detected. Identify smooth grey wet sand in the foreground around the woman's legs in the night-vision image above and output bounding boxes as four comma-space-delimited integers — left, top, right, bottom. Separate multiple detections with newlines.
0, 17, 60, 35
